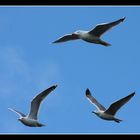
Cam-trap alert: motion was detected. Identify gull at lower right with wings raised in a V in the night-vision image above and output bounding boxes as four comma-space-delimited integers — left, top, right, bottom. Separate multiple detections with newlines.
86, 88, 135, 123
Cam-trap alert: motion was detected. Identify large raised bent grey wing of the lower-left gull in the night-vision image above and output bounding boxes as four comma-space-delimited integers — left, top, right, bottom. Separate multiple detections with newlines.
28, 85, 57, 120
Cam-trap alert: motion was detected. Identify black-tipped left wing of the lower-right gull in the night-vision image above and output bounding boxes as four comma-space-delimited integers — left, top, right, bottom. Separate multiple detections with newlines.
86, 89, 106, 111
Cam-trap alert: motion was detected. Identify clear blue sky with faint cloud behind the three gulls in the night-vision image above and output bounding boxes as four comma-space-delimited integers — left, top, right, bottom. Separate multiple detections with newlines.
0, 6, 140, 134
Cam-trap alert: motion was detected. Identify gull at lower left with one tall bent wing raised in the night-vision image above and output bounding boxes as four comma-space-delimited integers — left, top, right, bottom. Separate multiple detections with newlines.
8, 85, 57, 127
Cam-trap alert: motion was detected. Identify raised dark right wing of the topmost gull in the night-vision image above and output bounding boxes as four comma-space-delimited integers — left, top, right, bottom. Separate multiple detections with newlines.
89, 17, 125, 37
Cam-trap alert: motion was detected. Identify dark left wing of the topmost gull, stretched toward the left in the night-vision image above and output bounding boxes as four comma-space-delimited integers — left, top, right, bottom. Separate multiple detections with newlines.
53, 34, 79, 43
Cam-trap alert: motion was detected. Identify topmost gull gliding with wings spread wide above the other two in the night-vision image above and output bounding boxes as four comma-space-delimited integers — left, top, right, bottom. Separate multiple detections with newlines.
53, 17, 125, 47
